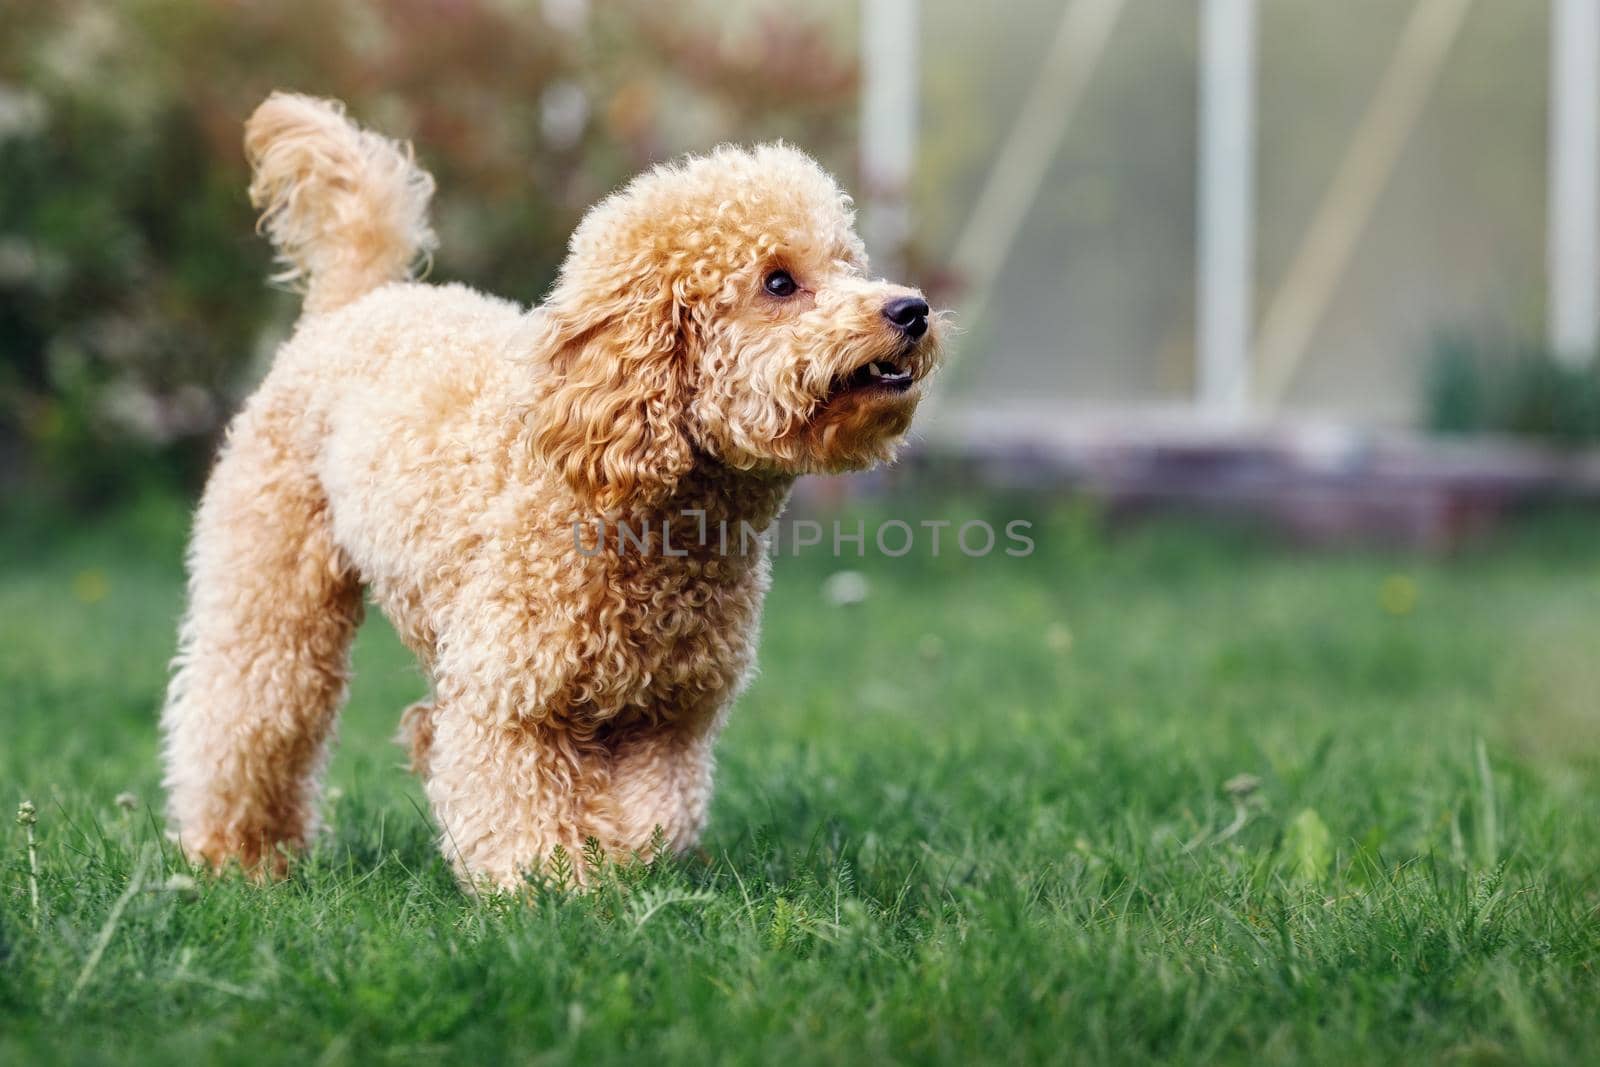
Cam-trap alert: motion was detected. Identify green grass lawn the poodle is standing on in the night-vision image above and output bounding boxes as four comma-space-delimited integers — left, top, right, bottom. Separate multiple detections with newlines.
0, 502, 1600, 1065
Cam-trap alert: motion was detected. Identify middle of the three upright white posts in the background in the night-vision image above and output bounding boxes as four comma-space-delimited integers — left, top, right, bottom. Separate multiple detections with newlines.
1195, 0, 1256, 419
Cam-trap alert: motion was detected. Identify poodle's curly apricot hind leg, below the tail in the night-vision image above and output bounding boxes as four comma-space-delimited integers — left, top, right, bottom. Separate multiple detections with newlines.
162, 397, 362, 872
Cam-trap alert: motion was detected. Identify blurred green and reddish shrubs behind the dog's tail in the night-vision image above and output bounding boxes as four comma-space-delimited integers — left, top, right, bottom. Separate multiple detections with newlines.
0, 0, 856, 502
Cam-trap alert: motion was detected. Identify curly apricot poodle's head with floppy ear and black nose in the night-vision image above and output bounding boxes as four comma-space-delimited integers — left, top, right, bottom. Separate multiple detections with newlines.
533, 146, 941, 509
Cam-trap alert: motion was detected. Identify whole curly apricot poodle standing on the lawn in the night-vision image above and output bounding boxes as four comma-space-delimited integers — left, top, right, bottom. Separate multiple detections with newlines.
163, 93, 941, 886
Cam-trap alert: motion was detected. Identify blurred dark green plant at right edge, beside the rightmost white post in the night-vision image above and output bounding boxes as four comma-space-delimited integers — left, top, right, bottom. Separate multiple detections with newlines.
1427, 336, 1600, 446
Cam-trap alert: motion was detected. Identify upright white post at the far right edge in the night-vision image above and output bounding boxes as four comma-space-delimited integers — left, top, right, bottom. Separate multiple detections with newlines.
1547, 0, 1600, 363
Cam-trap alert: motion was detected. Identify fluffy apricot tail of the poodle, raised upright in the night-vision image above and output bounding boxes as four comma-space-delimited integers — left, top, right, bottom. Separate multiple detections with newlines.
245, 93, 437, 312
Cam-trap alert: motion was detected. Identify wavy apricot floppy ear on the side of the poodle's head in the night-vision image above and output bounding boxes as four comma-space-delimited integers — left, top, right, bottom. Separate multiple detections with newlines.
530, 280, 694, 512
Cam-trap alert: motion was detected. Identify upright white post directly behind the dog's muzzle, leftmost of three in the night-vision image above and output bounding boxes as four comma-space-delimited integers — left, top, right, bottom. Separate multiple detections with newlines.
861, 0, 918, 280
